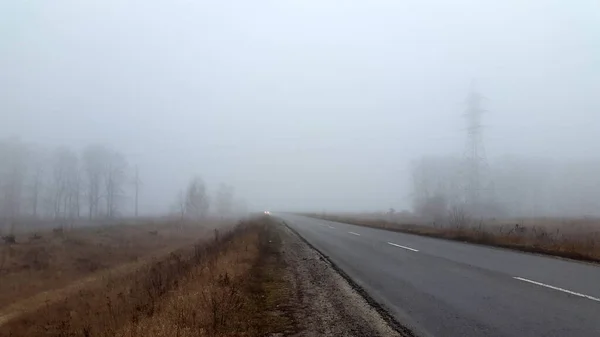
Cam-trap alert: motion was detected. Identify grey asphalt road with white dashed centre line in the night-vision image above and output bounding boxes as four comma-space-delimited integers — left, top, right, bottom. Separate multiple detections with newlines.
274, 214, 600, 337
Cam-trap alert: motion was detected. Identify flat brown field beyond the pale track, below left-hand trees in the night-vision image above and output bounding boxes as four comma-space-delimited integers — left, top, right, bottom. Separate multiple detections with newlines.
0, 222, 220, 312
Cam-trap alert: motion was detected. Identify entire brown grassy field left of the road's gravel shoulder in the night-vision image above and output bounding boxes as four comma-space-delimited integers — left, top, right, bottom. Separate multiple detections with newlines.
0, 218, 292, 337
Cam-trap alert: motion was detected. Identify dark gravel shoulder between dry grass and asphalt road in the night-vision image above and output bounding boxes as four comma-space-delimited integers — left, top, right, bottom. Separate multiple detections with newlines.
278, 222, 410, 337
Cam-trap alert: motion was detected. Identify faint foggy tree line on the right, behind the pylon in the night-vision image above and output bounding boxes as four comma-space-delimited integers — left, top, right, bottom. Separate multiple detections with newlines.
411, 156, 600, 221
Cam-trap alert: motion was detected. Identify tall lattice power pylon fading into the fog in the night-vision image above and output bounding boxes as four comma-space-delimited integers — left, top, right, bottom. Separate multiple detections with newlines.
464, 85, 488, 212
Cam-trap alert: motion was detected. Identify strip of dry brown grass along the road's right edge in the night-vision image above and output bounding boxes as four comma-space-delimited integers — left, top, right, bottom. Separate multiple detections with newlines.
309, 213, 600, 262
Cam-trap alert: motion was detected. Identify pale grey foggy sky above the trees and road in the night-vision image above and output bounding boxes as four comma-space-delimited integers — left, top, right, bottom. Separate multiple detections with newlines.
0, 0, 600, 211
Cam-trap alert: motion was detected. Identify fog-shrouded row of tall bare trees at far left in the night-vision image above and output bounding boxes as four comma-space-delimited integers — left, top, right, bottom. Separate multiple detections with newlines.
0, 139, 128, 231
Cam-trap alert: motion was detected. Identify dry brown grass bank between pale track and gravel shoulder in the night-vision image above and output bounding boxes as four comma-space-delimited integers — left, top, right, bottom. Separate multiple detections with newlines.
0, 219, 291, 337
